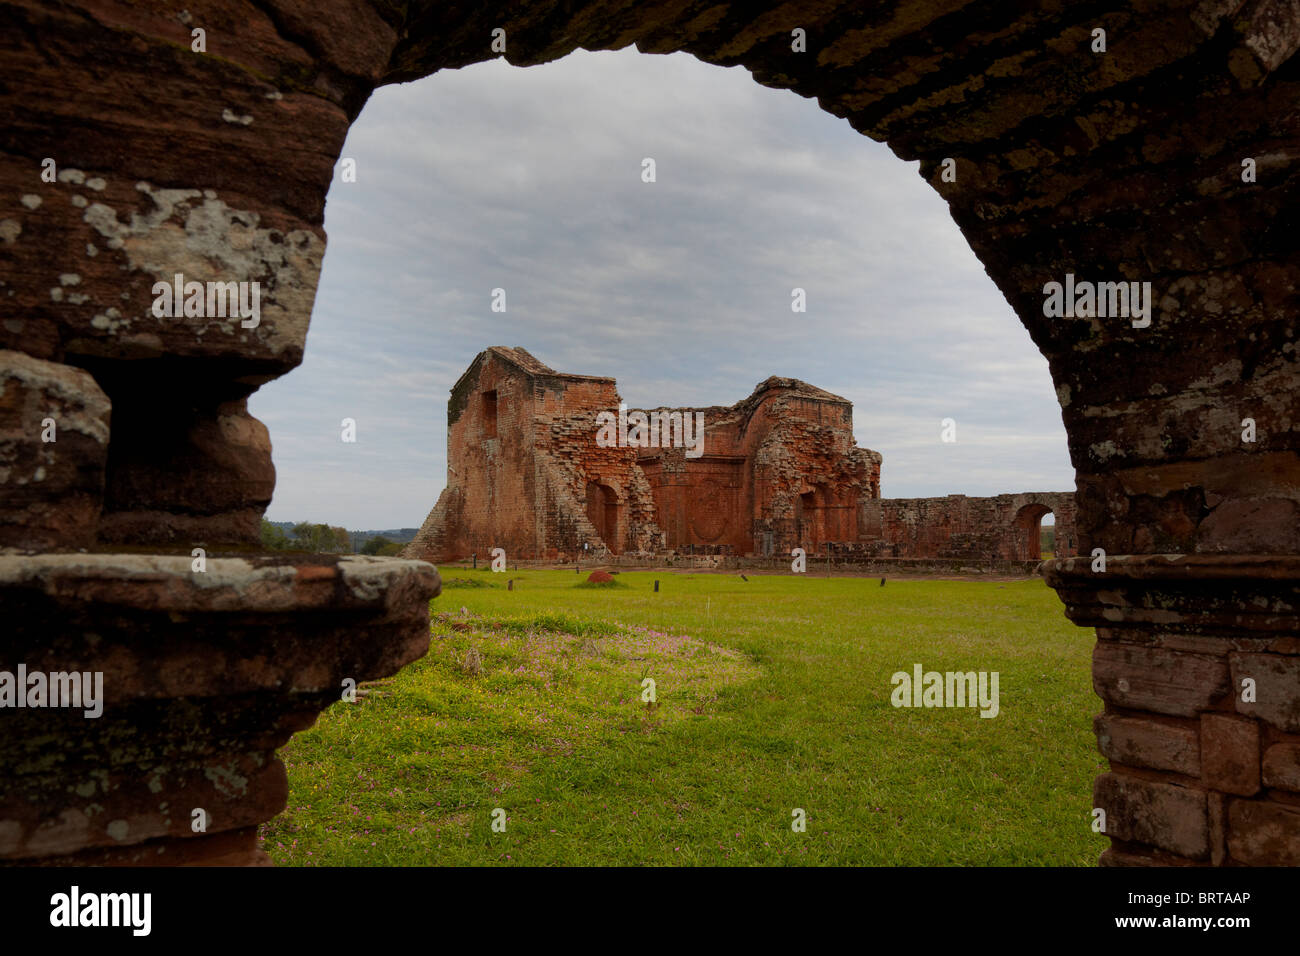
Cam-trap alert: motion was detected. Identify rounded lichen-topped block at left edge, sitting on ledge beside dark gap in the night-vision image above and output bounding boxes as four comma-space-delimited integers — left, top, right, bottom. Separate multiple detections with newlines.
0, 351, 111, 550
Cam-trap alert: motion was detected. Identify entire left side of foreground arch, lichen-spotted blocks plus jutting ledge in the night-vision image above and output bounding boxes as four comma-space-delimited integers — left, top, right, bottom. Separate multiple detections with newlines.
0, 0, 439, 865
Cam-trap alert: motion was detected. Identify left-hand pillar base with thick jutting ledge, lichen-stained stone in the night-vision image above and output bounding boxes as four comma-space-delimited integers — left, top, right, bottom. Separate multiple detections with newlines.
0, 553, 438, 865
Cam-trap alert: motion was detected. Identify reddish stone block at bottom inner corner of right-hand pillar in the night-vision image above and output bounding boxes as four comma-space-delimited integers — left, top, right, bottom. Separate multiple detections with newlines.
1092, 774, 1210, 860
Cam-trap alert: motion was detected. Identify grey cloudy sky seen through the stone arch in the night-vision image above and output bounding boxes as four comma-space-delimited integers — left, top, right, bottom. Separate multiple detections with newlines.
250, 49, 1074, 529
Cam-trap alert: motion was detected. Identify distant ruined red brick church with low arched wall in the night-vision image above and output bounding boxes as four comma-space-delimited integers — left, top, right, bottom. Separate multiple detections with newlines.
404, 346, 1078, 563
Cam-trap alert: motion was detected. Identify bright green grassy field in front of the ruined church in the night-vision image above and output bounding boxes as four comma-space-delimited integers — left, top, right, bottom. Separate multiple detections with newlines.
264, 568, 1106, 866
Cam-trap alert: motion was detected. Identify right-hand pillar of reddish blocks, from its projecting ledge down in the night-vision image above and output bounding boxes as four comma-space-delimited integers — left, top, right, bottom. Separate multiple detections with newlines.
1048, 554, 1300, 866
